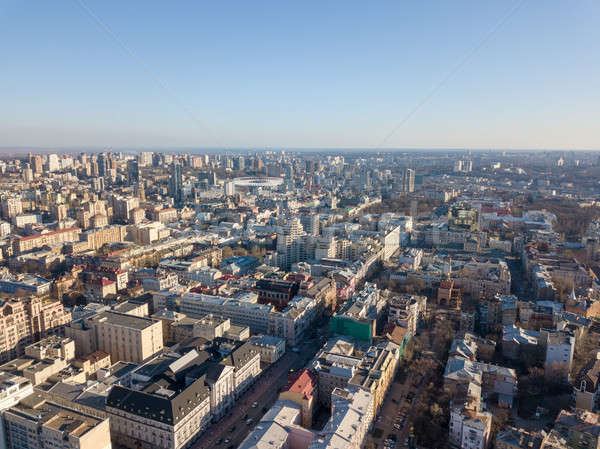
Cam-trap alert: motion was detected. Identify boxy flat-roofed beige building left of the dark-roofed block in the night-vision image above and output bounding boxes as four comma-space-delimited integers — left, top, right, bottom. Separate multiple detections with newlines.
66, 311, 163, 363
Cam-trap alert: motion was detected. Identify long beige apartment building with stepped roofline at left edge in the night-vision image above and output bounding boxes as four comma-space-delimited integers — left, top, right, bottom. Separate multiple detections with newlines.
0, 297, 71, 361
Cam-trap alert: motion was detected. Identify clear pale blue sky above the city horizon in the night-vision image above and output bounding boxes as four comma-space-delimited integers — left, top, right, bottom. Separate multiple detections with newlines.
0, 0, 600, 150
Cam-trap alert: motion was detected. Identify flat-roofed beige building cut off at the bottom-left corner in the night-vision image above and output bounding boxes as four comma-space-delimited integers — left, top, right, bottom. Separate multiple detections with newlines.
4, 394, 111, 449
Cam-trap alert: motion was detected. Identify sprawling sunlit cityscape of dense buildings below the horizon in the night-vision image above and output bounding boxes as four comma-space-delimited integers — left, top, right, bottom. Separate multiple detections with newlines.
0, 150, 600, 449
